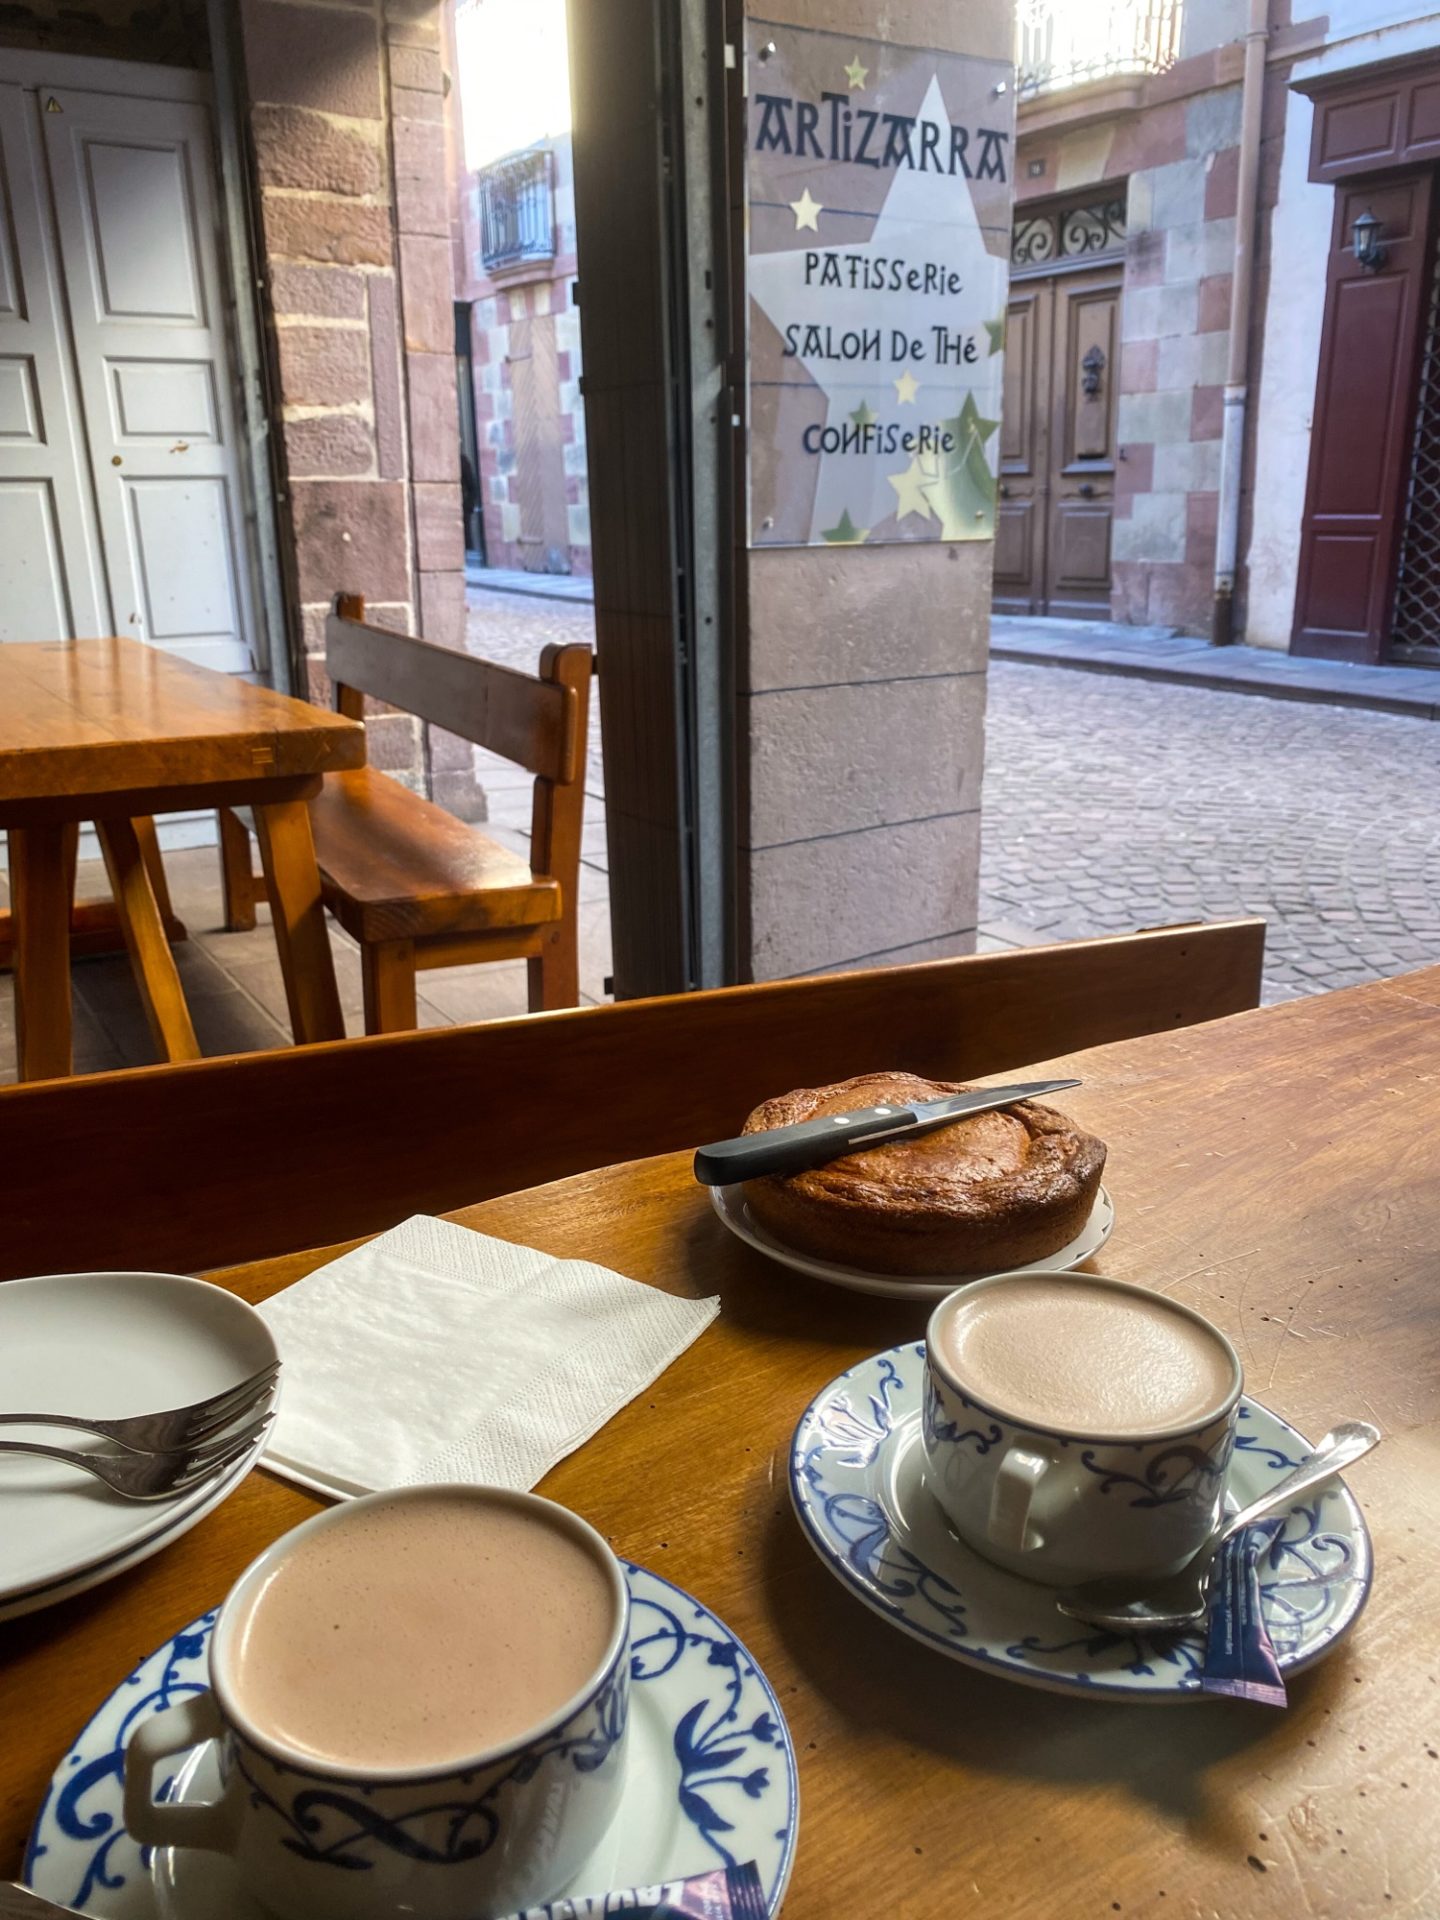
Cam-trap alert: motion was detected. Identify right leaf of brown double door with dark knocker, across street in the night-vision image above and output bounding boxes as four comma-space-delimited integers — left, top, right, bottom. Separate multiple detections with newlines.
1044, 267, 1121, 618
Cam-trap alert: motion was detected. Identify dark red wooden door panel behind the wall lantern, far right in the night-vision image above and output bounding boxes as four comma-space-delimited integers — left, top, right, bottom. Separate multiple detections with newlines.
1290, 171, 1432, 660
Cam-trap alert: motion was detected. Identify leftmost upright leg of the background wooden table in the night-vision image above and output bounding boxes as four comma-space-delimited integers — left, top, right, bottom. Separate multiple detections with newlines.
10, 822, 81, 1081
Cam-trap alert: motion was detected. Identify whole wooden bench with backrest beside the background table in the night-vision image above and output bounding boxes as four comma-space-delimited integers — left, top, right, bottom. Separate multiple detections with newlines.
221, 593, 591, 1033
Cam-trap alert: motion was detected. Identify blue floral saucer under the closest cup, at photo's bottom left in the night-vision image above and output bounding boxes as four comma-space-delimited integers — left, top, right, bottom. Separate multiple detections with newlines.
25, 1567, 799, 1920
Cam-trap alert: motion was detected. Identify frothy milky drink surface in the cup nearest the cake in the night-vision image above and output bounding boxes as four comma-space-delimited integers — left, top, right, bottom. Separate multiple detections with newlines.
937, 1273, 1235, 1438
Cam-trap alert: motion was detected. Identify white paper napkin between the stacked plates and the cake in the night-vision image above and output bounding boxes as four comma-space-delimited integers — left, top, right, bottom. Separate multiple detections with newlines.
259, 1213, 720, 1494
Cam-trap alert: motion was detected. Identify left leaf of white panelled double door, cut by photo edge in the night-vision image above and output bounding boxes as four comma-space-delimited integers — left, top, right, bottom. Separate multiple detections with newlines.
0, 86, 113, 641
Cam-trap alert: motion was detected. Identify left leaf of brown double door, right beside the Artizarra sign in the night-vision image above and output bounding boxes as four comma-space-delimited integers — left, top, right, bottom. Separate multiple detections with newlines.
995, 280, 1054, 612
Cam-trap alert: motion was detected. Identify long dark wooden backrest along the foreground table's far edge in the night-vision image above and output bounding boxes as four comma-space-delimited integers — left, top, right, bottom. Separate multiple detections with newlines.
0, 920, 1265, 1277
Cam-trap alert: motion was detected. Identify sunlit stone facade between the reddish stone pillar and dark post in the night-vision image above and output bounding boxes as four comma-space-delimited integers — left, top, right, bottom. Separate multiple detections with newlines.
453, 138, 593, 574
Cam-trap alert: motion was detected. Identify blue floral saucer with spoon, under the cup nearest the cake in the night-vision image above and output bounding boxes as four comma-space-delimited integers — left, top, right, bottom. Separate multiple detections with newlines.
789, 1342, 1371, 1701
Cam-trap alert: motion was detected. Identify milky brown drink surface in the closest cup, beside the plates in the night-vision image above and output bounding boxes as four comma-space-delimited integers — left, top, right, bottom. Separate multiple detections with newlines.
227, 1488, 616, 1770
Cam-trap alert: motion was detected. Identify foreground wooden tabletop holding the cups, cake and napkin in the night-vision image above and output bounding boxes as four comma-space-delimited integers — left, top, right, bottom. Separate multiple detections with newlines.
0, 968, 1440, 1920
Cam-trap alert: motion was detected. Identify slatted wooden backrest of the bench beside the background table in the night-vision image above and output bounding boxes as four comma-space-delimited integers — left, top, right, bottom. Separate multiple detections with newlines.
324, 593, 591, 785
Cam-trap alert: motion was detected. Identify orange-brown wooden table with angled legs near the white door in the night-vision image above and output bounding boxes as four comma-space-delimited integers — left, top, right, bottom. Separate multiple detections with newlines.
0, 639, 365, 1079
